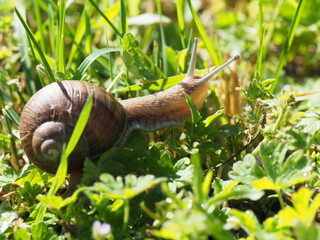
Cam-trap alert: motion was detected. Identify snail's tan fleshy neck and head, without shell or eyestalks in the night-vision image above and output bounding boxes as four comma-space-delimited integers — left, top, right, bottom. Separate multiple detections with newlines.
120, 79, 210, 131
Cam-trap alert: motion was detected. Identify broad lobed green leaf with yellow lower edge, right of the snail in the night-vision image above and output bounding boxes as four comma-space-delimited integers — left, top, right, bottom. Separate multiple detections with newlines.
229, 141, 313, 191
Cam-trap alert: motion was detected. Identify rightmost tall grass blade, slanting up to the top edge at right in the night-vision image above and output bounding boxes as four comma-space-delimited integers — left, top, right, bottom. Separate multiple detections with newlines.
270, 0, 307, 93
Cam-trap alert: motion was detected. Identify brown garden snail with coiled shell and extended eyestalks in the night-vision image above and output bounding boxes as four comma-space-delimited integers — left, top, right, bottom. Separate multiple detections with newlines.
19, 39, 239, 173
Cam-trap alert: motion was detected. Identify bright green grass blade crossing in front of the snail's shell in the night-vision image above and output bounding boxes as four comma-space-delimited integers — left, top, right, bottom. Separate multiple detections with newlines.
30, 95, 93, 224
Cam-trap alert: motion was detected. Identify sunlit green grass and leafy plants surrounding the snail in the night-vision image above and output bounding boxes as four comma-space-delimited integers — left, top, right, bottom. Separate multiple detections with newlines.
0, 0, 320, 240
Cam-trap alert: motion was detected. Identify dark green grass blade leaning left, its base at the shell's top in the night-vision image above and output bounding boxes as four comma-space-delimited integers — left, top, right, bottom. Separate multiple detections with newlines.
14, 8, 56, 83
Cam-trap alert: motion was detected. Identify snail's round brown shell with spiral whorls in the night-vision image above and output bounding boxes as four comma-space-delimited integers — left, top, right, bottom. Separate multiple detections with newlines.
19, 81, 127, 173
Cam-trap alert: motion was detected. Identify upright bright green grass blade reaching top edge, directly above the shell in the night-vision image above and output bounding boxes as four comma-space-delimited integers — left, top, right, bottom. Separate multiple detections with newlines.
56, 0, 66, 73
